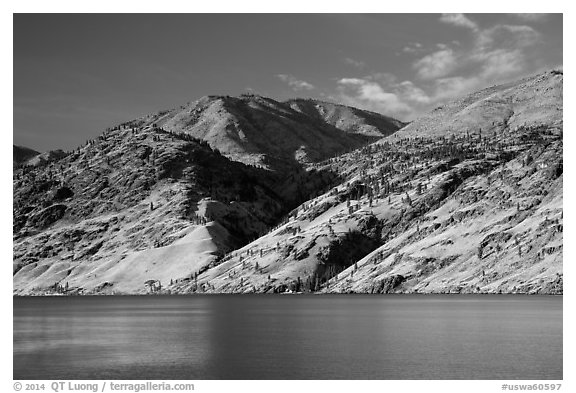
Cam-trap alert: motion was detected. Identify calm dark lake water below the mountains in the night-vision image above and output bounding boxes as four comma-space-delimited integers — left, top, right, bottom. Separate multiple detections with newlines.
13, 295, 562, 380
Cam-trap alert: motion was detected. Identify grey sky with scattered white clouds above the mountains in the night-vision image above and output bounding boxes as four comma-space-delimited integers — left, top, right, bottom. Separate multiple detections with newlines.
13, 14, 563, 151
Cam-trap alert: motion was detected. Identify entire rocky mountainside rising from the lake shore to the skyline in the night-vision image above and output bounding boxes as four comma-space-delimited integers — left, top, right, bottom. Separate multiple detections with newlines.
14, 71, 563, 294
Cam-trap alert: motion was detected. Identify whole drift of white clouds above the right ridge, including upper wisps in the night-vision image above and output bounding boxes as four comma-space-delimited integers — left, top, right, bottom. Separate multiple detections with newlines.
328, 14, 546, 120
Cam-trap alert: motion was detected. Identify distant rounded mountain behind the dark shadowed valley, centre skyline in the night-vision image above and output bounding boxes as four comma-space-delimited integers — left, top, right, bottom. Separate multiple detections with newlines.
142, 95, 403, 171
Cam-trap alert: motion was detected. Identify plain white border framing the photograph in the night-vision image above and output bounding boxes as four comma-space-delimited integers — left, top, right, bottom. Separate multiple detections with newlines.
0, 0, 576, 393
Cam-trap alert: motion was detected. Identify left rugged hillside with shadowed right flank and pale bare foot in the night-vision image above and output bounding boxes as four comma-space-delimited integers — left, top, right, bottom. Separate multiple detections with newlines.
14, 126, 296, 293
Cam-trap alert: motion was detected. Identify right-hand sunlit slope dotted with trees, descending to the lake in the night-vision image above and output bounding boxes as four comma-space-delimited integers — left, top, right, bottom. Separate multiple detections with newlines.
171, 72, 563, 293
